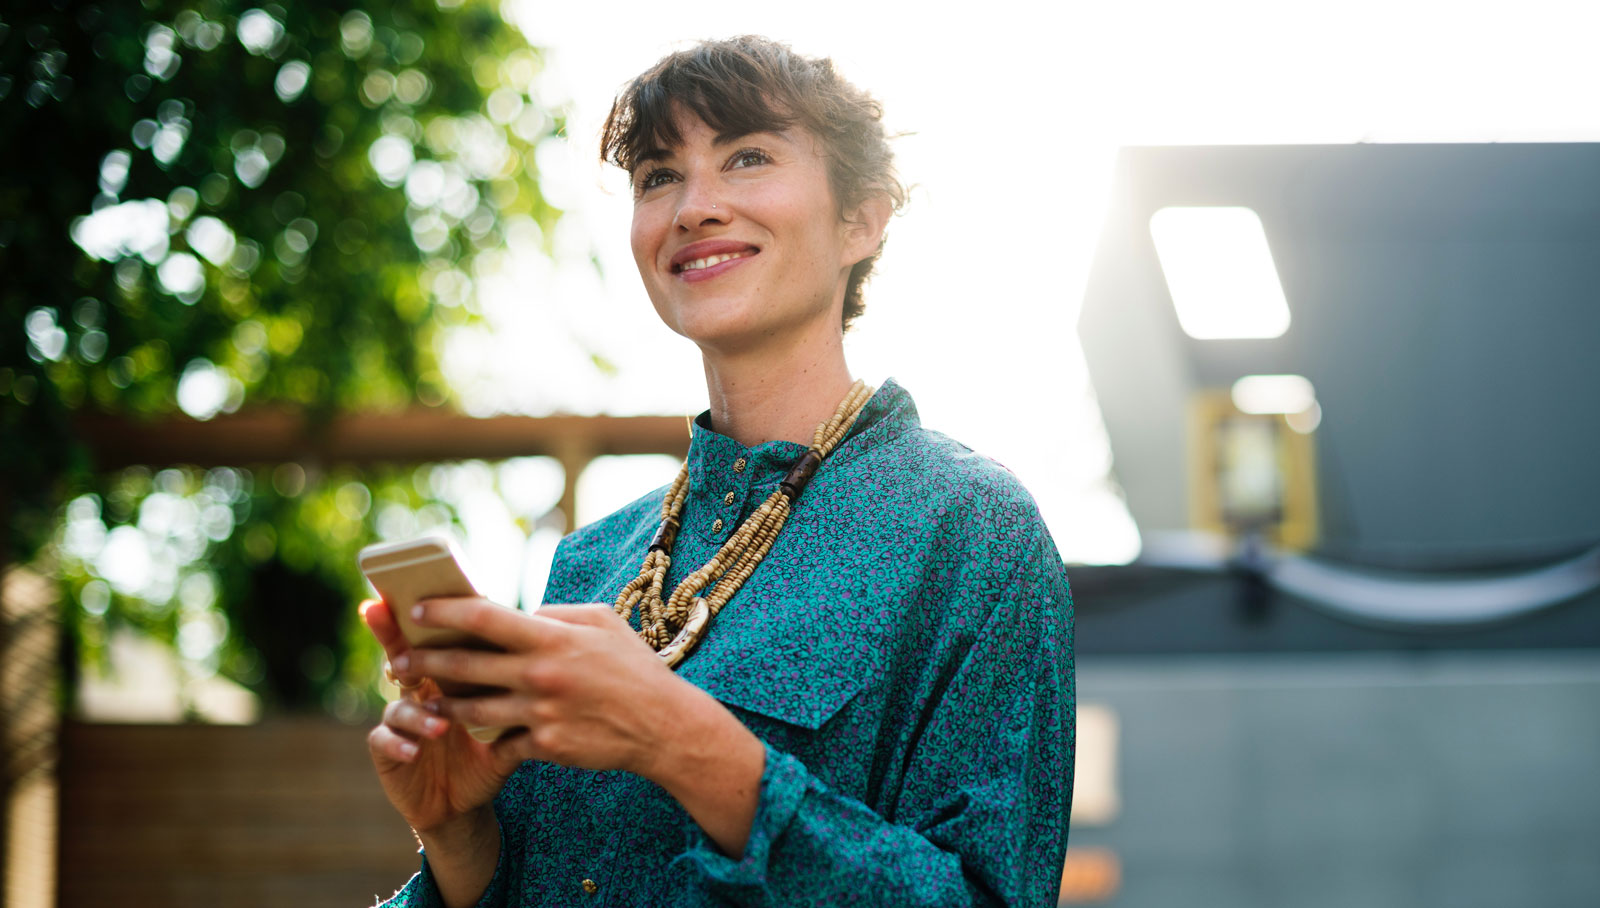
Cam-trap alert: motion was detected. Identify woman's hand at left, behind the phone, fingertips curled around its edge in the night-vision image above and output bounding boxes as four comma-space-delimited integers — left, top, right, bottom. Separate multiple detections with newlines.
362, 601, 517, 834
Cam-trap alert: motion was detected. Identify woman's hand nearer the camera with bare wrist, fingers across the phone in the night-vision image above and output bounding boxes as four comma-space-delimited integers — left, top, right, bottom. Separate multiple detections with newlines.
406, 599, 766, 858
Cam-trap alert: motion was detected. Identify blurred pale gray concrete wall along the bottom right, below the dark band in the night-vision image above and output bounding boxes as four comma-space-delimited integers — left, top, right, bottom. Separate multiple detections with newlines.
1072, 651, 1600, 908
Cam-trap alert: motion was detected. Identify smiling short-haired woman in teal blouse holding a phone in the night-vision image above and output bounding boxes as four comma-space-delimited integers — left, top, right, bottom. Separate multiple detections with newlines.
363, 38, 1074, 906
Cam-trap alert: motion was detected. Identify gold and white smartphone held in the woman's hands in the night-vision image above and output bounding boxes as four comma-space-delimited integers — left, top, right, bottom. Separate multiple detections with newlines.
357, 536, 506, 742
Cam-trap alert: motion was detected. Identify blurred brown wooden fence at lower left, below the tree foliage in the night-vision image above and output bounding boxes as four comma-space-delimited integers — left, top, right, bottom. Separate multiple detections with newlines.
58, 719, 419, 908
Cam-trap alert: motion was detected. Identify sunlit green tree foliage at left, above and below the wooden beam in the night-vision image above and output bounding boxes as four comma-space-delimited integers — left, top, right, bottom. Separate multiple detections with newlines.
0, 0, 576, 719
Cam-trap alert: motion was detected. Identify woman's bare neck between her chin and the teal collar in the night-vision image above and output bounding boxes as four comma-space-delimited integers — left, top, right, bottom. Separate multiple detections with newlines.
702, 326, 853, 448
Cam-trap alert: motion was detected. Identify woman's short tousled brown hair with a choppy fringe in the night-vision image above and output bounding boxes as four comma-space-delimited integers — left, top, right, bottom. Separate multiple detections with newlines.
600, 35, 906, 329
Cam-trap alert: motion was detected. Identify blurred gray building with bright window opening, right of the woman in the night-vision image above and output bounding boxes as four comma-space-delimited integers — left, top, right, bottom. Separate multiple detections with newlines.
1070, 144, 1600, 908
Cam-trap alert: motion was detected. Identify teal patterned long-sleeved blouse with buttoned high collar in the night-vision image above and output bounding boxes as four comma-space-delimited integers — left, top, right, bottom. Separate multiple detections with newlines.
377, 380, 1075, 908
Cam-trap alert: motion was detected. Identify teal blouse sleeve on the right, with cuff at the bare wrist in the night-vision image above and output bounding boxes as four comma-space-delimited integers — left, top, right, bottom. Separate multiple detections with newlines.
678, 532, 1075, 906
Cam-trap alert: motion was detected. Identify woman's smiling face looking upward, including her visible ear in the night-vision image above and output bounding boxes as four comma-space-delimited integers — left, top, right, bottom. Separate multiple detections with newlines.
632, 115, 882, 353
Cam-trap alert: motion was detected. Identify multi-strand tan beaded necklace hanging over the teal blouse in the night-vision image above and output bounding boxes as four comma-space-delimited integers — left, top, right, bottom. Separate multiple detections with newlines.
613, 382, 874, 667
